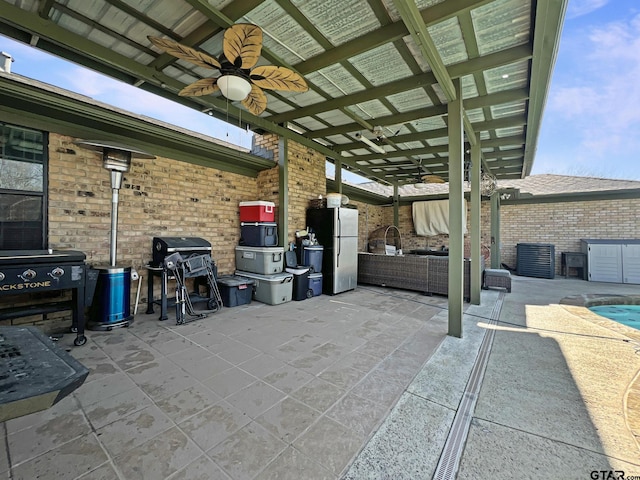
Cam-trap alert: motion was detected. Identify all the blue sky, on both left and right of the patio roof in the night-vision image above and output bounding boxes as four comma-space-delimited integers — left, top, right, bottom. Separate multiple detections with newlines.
0, 0, 640, 180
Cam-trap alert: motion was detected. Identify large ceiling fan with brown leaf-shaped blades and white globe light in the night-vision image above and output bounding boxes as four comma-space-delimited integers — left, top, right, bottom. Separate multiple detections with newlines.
147, 23, 309, 115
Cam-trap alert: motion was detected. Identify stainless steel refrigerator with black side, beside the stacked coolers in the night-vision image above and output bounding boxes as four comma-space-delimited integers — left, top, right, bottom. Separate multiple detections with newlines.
307, 208, 358, 295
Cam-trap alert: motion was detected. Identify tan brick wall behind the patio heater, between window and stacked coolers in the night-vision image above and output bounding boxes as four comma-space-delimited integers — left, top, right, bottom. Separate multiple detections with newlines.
49, 134, 258, 275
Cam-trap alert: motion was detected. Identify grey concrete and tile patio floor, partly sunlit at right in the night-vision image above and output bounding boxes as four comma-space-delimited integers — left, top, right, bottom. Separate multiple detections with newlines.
0, 277, 640, 480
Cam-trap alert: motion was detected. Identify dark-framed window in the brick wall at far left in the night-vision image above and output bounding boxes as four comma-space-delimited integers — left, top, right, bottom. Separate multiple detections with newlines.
0, 122, 48, 250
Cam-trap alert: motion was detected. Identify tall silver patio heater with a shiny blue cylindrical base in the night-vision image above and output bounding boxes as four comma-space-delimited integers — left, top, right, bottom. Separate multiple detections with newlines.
77, 140, 155, 331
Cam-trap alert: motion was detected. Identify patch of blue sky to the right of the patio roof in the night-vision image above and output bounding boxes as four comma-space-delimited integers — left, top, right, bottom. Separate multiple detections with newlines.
532, 0, 640, 180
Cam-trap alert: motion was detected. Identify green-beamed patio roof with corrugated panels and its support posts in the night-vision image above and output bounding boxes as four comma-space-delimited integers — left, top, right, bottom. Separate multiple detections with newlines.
0, 0, 567, 336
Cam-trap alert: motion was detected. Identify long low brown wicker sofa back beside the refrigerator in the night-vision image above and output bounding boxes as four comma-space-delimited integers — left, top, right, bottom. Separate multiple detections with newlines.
358, 252, 484, 301
